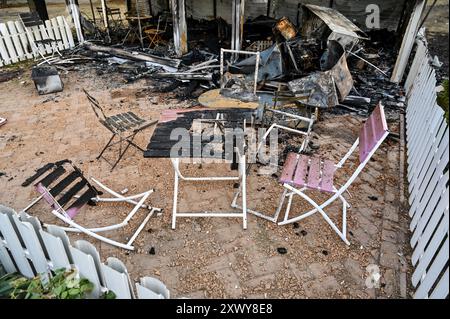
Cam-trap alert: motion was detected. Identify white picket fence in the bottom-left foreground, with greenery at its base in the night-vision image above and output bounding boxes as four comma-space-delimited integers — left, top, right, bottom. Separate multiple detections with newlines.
0, 205, 170, 299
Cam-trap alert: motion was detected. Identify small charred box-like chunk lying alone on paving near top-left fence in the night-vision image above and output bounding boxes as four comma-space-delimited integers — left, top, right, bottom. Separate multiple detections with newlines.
31, 66, 64, 95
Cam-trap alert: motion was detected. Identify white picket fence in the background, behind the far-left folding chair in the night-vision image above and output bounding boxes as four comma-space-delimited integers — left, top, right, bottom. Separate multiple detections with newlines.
0, 16, 75, 67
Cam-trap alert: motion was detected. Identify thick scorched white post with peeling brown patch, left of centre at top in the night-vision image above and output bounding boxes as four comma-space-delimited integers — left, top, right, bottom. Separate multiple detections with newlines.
171, 0, 188, 57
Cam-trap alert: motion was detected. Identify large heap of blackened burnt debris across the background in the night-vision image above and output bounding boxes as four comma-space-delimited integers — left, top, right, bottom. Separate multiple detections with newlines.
14, 5, 405, 116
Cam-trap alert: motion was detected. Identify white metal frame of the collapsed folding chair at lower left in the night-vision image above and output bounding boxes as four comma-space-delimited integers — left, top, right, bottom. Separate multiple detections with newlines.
22, 178, 161, 250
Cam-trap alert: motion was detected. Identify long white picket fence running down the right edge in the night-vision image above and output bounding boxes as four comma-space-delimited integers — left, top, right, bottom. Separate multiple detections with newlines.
405, 37, 449, 299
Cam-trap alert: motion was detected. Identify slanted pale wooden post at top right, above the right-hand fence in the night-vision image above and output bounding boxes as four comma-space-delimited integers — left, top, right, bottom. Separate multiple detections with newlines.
391, 0, 426, 83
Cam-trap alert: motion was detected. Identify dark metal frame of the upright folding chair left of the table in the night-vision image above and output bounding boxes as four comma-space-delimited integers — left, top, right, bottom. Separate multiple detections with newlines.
83, 89, 158, 171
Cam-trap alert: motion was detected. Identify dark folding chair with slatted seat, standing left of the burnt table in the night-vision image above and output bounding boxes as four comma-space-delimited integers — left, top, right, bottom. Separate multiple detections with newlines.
83, 89, 158, 171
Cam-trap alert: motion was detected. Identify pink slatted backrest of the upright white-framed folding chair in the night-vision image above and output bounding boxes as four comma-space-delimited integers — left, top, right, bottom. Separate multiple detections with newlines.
359, 103, 389, 163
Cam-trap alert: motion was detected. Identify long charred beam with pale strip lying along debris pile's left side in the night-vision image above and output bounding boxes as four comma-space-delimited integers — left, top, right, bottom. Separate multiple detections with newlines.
84, 42, 181, 68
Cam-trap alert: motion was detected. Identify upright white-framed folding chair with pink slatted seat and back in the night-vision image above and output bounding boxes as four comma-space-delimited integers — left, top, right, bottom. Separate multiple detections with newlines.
275, 103, 389, 245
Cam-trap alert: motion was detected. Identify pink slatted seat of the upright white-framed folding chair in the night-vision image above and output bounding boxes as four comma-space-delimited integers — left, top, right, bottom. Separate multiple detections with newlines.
280, 153, 336, 193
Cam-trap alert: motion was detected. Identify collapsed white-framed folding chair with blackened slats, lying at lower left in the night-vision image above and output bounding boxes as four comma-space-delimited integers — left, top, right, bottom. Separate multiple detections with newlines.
22, 160, 161, 250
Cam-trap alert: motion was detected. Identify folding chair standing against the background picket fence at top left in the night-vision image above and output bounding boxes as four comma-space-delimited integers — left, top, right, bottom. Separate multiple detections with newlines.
19, 12, 62, 64
